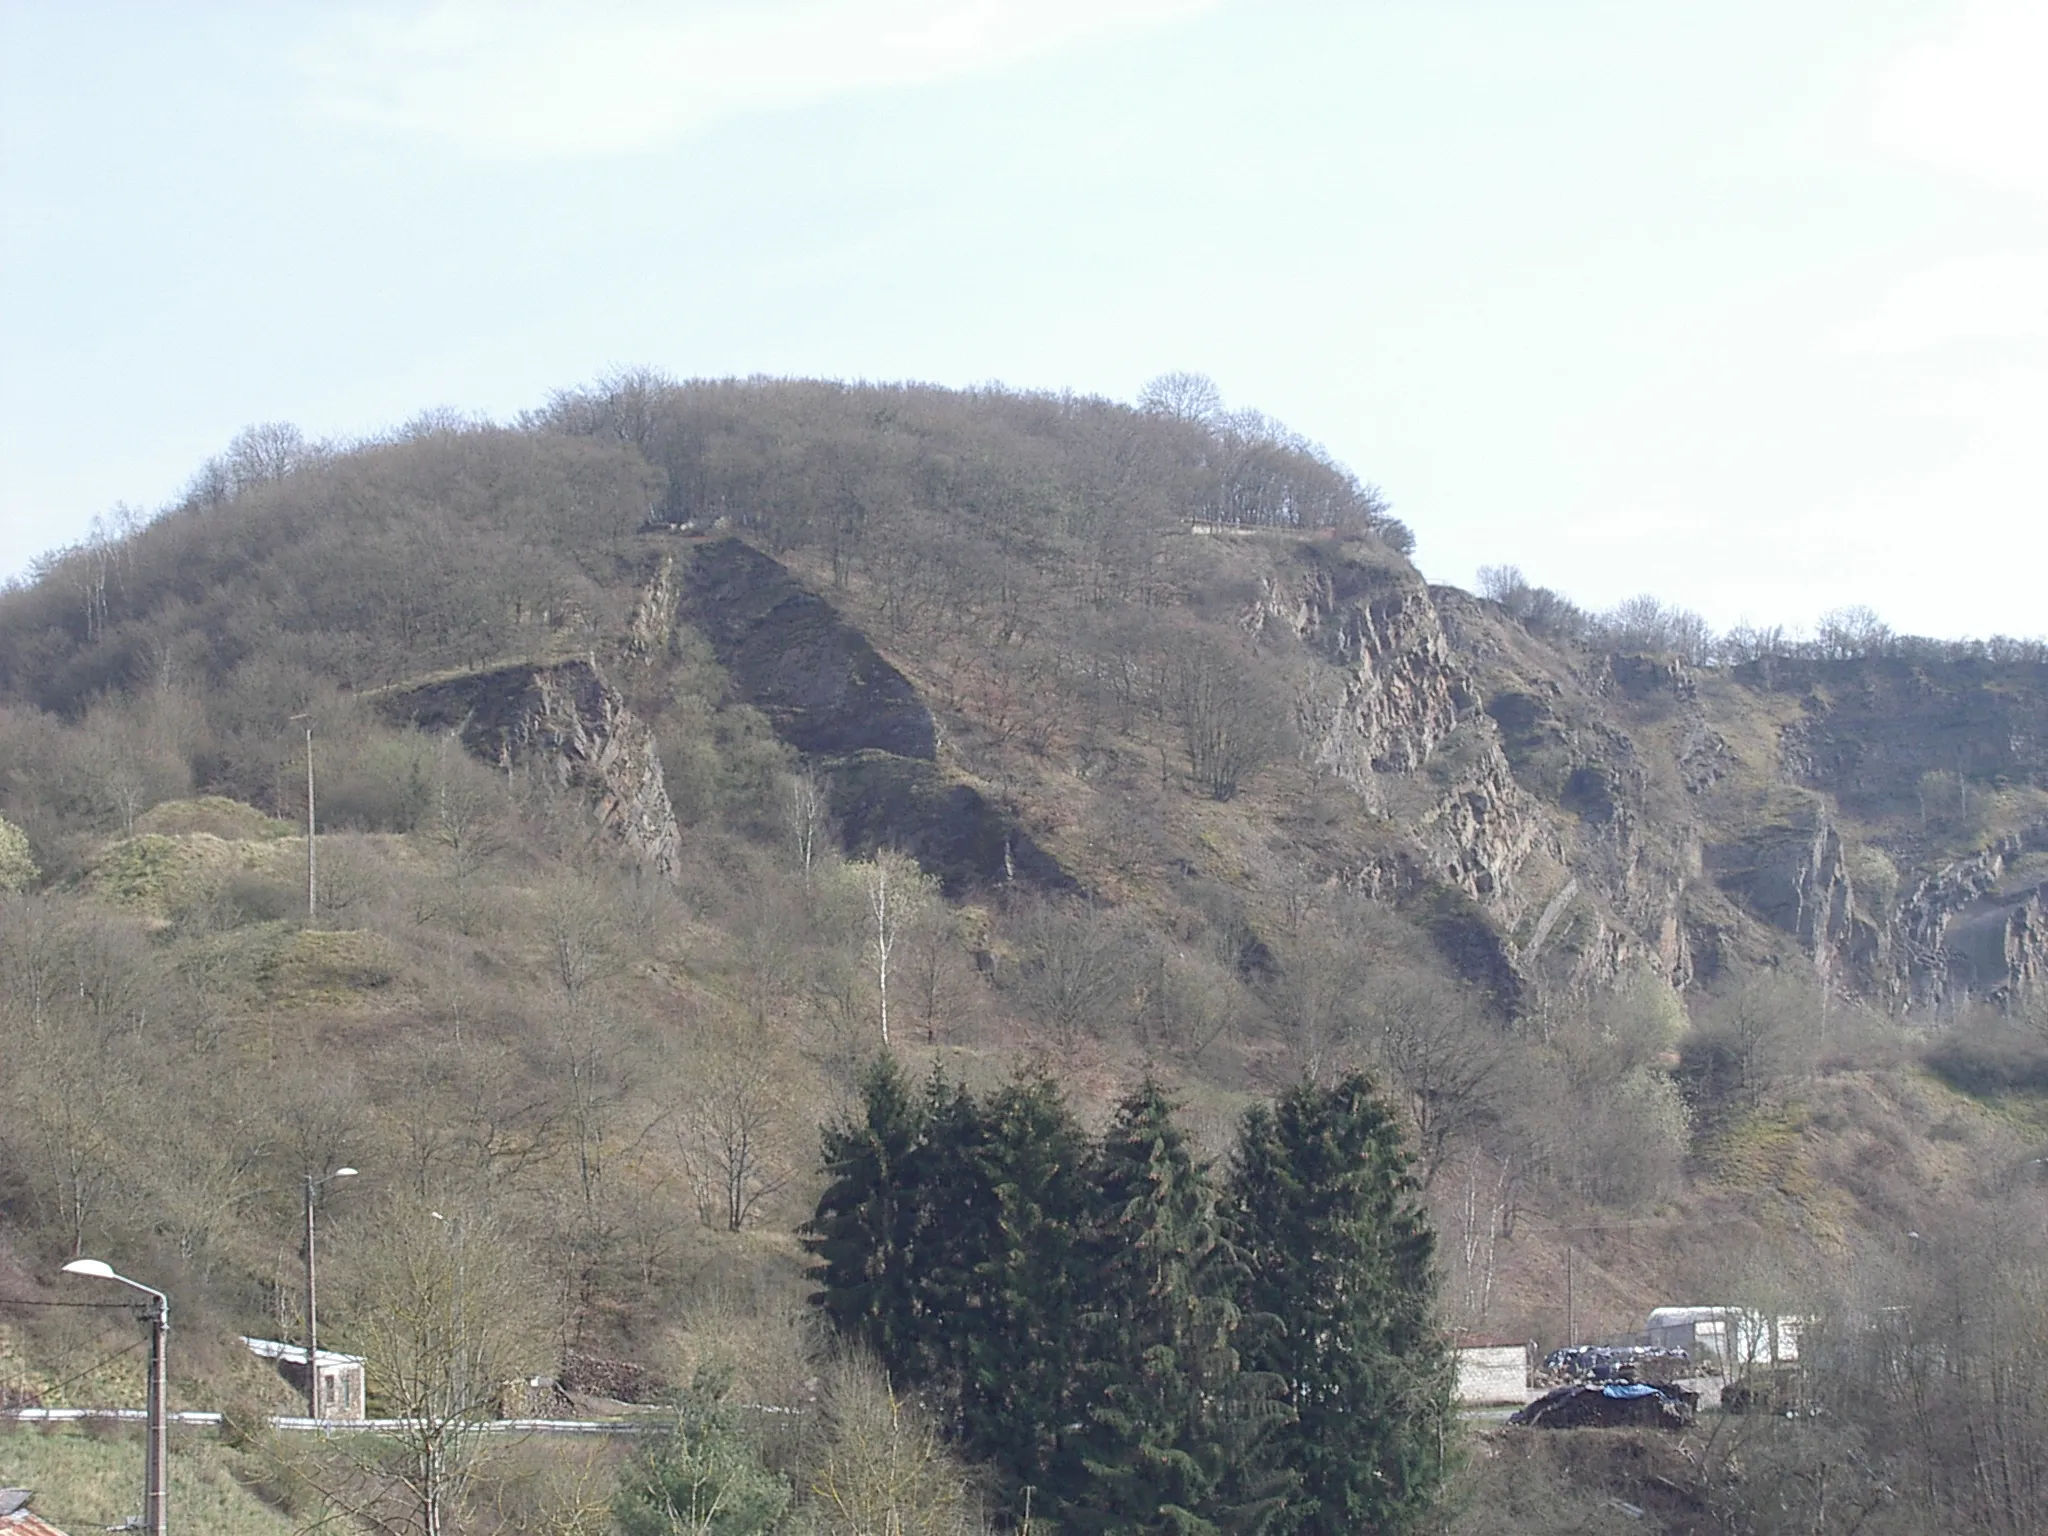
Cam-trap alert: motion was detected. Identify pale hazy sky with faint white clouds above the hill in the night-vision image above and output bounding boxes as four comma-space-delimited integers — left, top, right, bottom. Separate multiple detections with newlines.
0, 0, 2048, 635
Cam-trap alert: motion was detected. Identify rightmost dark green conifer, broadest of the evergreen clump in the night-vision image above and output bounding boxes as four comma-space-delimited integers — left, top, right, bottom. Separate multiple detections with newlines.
1225, 1073, 1450, 1536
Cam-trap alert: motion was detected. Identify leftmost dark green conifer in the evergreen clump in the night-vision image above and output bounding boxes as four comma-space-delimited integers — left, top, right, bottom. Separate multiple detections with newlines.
803, 1055, 928, 1376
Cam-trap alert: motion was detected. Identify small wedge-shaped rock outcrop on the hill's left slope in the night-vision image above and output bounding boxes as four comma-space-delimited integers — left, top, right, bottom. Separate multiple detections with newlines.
381, 659, 680, 879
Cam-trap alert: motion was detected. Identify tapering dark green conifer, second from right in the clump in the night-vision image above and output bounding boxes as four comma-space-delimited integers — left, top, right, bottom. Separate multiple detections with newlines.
1057, 1081, 1257, 1536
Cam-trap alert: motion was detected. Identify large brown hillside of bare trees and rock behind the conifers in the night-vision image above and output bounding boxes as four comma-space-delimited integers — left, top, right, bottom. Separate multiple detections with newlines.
0, 375, 2048, 1536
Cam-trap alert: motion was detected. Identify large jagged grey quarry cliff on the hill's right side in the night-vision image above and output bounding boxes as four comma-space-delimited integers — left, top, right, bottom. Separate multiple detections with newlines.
1243, 541, 2048, 1012
